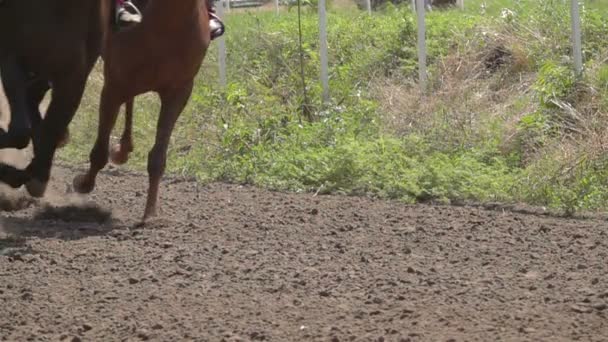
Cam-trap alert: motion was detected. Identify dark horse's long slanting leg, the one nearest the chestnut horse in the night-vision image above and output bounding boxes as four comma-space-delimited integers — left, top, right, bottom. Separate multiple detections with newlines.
26, 67, 87, 197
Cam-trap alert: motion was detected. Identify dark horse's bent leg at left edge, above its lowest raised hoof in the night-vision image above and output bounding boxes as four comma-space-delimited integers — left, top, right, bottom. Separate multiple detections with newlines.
0, 57, 31, 149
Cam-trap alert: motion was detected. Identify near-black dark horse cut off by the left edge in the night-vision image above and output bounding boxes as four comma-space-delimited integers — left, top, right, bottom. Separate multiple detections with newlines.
0, 0, 111, 196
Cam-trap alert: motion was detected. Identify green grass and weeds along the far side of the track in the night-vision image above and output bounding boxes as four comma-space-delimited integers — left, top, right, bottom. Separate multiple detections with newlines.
60, 0, 608, 212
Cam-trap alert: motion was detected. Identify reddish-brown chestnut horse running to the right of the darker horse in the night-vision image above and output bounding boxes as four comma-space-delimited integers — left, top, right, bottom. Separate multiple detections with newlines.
74, 0, 211, 222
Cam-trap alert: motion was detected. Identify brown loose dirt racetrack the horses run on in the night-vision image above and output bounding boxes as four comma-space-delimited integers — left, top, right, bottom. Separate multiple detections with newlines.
0, 167, 608, 341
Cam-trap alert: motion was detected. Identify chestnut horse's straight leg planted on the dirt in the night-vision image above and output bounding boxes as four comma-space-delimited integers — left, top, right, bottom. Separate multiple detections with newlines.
143, 81, 192, 222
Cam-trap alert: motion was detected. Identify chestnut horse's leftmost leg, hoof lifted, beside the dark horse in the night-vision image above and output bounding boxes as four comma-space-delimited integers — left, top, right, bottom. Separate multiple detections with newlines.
74, 85, 123, 193
